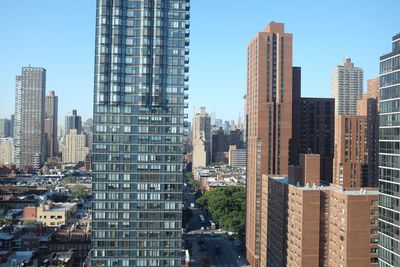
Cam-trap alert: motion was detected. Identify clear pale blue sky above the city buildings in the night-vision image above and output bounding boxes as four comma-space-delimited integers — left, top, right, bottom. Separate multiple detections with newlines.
0, 0, 400, 122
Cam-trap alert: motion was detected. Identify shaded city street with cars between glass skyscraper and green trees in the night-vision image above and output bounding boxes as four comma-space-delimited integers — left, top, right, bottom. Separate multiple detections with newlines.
184, 183, 247, 267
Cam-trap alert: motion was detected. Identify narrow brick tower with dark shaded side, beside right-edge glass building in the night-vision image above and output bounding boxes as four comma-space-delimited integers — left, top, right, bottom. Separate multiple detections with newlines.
357, 78, 379, 187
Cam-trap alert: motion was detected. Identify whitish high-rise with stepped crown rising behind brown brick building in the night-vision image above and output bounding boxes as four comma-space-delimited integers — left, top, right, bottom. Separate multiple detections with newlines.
332, 58, 364, 116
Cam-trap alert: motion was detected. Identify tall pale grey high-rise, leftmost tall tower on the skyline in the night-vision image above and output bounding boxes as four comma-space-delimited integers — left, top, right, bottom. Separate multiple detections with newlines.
14, 67, 46, 167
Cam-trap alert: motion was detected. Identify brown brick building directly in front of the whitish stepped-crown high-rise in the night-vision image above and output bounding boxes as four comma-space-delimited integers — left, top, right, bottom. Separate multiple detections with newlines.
333, 115, 368, 187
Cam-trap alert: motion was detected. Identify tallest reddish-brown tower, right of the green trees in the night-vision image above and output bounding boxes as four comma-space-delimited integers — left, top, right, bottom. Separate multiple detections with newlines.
246, 22, 292, 266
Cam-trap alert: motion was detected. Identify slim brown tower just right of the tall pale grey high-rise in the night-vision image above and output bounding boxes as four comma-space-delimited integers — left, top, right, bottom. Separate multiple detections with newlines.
45, 91, 58, 160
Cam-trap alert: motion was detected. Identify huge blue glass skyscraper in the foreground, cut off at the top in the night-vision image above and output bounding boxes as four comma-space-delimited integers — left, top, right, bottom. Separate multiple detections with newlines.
92, 0, 190, 266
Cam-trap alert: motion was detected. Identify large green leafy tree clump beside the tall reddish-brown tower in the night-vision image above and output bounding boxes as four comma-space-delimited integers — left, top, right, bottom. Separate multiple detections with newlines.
197, 186, 246, 233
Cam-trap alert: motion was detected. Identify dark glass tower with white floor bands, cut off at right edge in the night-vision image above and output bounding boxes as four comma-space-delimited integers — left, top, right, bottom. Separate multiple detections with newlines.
379, 33, 400, 267
